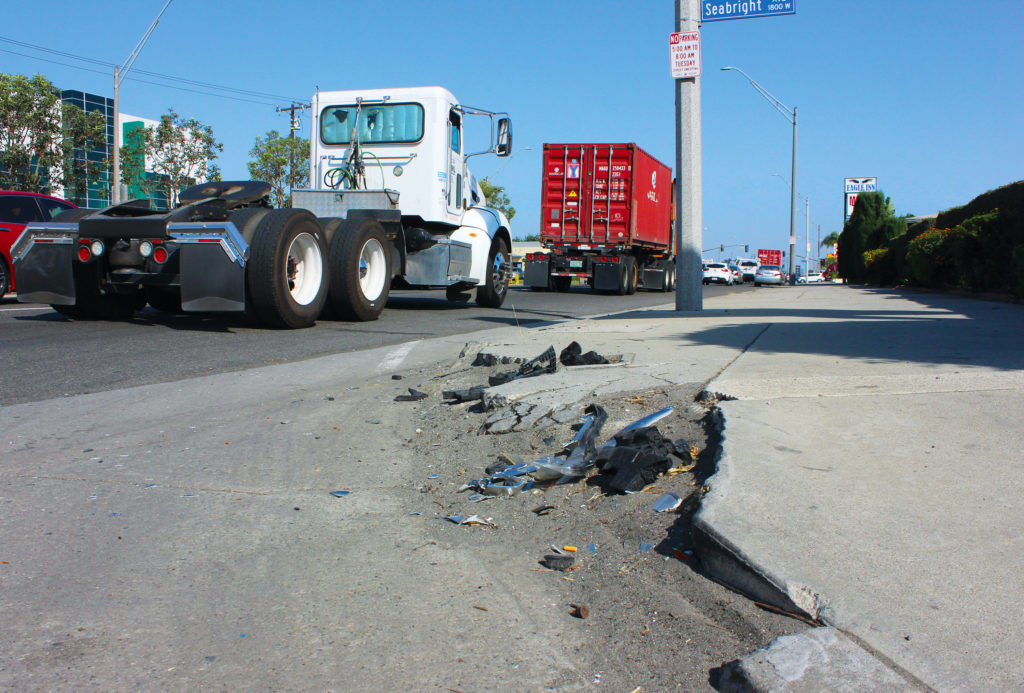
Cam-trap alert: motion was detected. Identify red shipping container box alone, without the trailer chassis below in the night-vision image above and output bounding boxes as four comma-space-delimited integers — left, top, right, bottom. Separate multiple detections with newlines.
541, 143, 673, 252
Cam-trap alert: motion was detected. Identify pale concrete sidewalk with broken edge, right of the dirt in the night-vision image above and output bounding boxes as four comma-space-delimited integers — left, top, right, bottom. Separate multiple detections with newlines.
479, 286, 1024, 691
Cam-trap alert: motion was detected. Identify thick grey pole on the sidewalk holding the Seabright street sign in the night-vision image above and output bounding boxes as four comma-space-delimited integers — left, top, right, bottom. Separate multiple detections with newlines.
676, 0, 703, 311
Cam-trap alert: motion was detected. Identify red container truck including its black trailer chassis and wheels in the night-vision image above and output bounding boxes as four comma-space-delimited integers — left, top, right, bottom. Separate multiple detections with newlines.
523, 143, 676, 295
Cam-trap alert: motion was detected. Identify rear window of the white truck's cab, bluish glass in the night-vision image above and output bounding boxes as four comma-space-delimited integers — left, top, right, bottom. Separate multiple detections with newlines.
321, 103, 423, 144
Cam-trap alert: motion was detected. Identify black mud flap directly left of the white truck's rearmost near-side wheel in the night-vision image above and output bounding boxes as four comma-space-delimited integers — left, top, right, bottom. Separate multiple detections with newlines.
178, 243, 246, 312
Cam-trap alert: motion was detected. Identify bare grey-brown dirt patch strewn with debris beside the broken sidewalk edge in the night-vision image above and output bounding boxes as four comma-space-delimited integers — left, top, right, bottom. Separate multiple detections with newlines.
387, 359, 806, 691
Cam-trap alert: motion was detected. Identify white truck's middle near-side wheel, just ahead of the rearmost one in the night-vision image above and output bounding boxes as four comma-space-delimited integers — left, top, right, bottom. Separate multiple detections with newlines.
331, 219, 391, 321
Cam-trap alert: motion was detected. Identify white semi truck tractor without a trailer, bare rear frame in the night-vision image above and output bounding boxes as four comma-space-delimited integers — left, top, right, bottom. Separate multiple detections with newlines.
12, 87, 512, 328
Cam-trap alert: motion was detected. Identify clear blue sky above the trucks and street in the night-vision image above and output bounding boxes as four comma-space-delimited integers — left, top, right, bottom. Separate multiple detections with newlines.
0, 0, 1024, 257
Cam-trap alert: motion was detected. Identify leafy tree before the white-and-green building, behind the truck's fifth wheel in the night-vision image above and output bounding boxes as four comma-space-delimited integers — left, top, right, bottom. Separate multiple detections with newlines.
145, 109, 224, 207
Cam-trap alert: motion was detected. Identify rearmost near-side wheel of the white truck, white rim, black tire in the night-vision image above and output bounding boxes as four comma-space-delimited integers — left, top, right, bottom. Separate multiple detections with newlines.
246, 209, 329, 329
